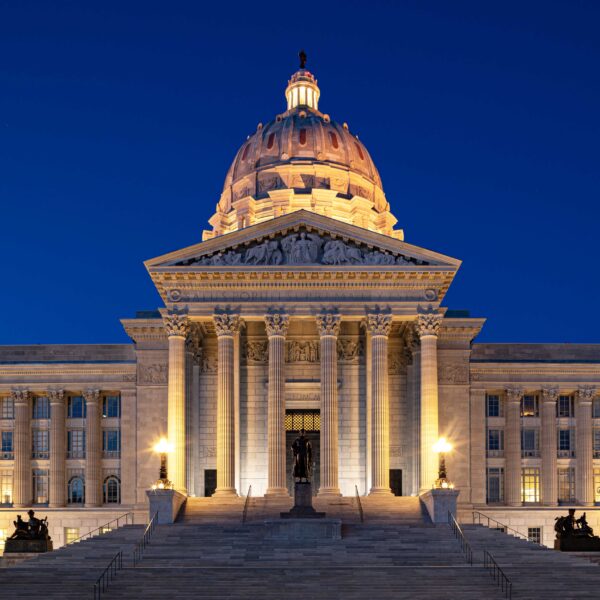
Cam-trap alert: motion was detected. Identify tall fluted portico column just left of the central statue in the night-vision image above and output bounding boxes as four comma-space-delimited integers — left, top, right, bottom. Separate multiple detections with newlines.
265, 314, 289, 496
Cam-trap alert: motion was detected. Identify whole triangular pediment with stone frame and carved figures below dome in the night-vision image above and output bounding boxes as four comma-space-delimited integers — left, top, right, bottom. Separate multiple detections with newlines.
145, 210, 460, 271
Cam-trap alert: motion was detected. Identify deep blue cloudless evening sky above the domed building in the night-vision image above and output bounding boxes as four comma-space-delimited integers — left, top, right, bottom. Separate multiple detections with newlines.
0, 0, 600, 344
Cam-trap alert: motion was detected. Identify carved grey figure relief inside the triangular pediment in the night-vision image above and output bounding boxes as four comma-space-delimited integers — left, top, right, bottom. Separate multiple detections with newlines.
177, 231, 429, 267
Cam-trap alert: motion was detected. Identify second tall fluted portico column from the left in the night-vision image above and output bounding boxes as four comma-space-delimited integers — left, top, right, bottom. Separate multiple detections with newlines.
213, 314, 240, 496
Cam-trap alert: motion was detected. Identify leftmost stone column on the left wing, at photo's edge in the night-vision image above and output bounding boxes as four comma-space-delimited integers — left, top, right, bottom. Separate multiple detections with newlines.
11, 390, 32, 508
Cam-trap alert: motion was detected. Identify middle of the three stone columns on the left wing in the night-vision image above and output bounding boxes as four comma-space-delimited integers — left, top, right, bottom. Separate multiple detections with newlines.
48, 390, 66, 508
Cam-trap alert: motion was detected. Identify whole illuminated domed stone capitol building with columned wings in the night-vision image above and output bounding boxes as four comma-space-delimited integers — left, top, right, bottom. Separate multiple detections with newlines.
0, 58, 600, 547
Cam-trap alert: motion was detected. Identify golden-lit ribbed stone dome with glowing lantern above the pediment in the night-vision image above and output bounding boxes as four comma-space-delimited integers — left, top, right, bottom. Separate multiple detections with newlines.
203, 61, 403, 239
